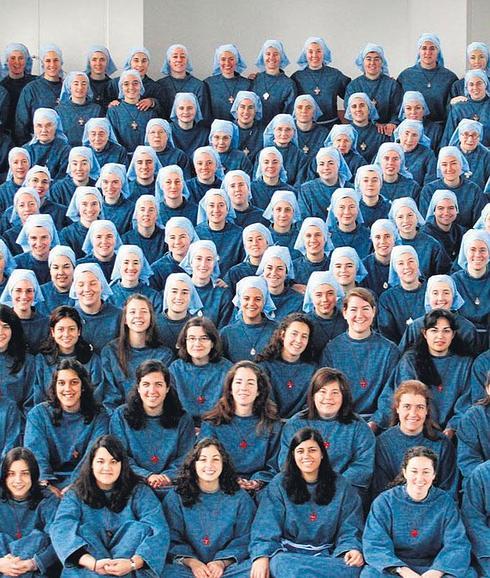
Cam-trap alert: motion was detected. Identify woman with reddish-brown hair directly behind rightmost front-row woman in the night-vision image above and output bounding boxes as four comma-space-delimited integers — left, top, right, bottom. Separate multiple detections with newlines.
372, 379, 459, 497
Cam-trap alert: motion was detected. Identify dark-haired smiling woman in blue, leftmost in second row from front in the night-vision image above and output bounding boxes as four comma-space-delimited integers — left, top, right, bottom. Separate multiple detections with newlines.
24, 359, 109, 498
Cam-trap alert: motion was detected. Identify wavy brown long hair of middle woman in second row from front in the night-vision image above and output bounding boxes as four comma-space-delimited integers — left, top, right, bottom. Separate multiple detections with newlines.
203, 360, 279, 434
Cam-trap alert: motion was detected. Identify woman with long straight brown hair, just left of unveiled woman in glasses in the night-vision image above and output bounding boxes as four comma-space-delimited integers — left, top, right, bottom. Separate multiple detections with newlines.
100, 293, 174, 412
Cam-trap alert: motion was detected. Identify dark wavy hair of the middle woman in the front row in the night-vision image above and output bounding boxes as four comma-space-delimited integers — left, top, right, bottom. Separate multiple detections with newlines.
176, 438, 240, 508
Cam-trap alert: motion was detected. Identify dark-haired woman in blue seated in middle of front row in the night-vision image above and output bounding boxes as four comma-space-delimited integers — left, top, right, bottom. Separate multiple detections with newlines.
163, 438, 255, 578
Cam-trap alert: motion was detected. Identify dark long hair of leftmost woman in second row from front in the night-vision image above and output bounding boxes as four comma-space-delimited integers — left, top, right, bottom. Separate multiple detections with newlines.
47, 359, 100, 427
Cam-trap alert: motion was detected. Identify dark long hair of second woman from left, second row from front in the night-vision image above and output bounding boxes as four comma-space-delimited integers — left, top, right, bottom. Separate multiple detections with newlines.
124, 359, 184, 430
